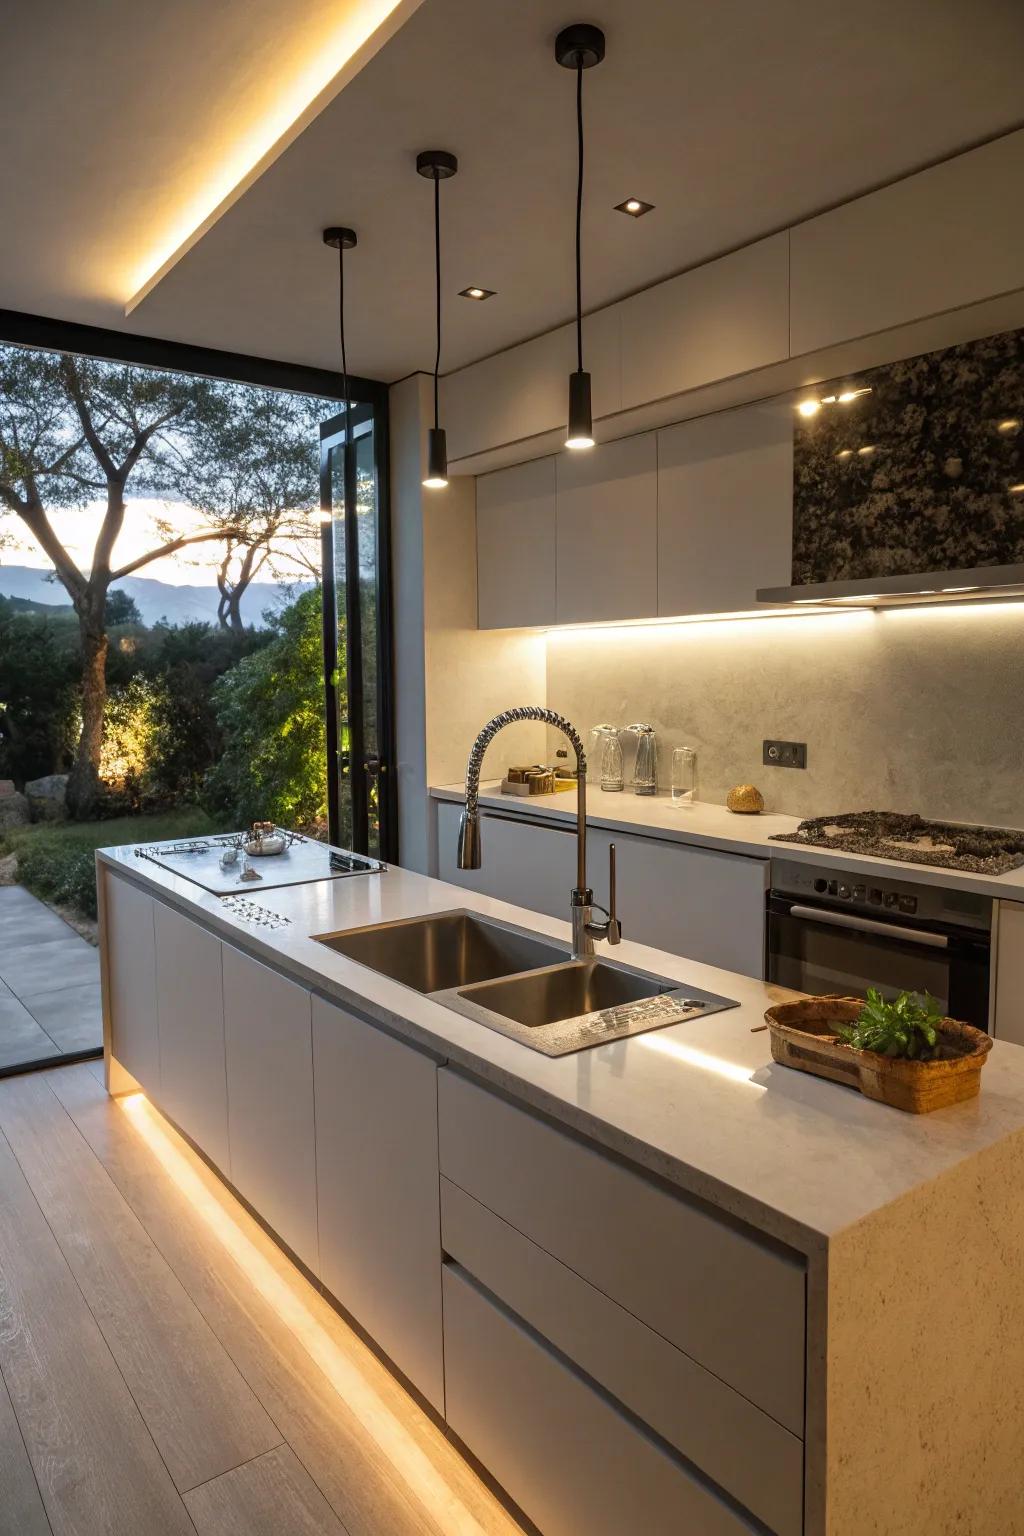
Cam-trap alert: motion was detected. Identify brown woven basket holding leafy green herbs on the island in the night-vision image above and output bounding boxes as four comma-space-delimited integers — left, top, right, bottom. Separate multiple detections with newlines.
765, 997, 992, 1115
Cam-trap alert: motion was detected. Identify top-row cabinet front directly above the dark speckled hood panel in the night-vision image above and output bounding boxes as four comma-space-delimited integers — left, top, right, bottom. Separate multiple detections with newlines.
791, 129, 1024, 356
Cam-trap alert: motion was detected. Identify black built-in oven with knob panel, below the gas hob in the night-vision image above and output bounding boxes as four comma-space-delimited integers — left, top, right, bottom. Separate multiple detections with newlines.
768, 859, 992, 1029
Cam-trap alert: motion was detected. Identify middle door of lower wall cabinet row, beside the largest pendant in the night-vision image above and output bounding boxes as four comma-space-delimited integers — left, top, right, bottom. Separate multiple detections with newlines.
554, 432, 657, 624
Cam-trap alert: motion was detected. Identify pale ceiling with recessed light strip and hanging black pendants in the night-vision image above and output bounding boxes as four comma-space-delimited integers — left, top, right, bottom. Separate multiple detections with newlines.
0, 0, 1024, 379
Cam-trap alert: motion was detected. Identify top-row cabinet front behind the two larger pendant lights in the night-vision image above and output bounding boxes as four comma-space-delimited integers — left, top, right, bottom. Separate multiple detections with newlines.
441, 304, 622, 461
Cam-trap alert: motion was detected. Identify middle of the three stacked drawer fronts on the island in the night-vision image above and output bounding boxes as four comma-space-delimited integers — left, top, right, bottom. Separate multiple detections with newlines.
441, 1178, 803, 1536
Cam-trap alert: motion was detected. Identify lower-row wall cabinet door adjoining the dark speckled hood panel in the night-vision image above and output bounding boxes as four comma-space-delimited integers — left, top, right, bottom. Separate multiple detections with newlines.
657, 401, 792, 617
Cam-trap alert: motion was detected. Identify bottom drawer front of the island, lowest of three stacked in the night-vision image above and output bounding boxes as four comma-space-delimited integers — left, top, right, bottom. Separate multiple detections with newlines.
444, 1266, 754, 1536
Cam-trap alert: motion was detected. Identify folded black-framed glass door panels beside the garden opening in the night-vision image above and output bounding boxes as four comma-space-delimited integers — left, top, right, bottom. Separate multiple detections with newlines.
321, 402, 398, 860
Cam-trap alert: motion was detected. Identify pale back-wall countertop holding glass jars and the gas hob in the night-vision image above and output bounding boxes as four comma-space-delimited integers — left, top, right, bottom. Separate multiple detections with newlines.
430, 770, 1024, 902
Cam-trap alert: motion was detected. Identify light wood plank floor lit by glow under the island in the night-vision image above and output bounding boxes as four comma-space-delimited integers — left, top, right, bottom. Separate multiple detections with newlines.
0, 1061, 519, 1536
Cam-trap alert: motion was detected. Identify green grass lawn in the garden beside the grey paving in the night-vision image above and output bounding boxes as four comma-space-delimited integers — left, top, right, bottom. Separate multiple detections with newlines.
0, 805, 213, 917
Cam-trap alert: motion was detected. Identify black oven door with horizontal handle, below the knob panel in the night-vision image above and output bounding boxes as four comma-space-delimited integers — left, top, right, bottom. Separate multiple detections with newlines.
768, 892, 990, 1029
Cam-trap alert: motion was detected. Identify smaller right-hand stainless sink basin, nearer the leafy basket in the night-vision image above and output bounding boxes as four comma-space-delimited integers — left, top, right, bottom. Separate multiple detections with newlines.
459, 960, 679, 1029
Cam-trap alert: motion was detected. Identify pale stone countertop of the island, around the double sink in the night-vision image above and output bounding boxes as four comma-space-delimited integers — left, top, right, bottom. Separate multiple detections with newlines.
98, 841, 1024, 1253
